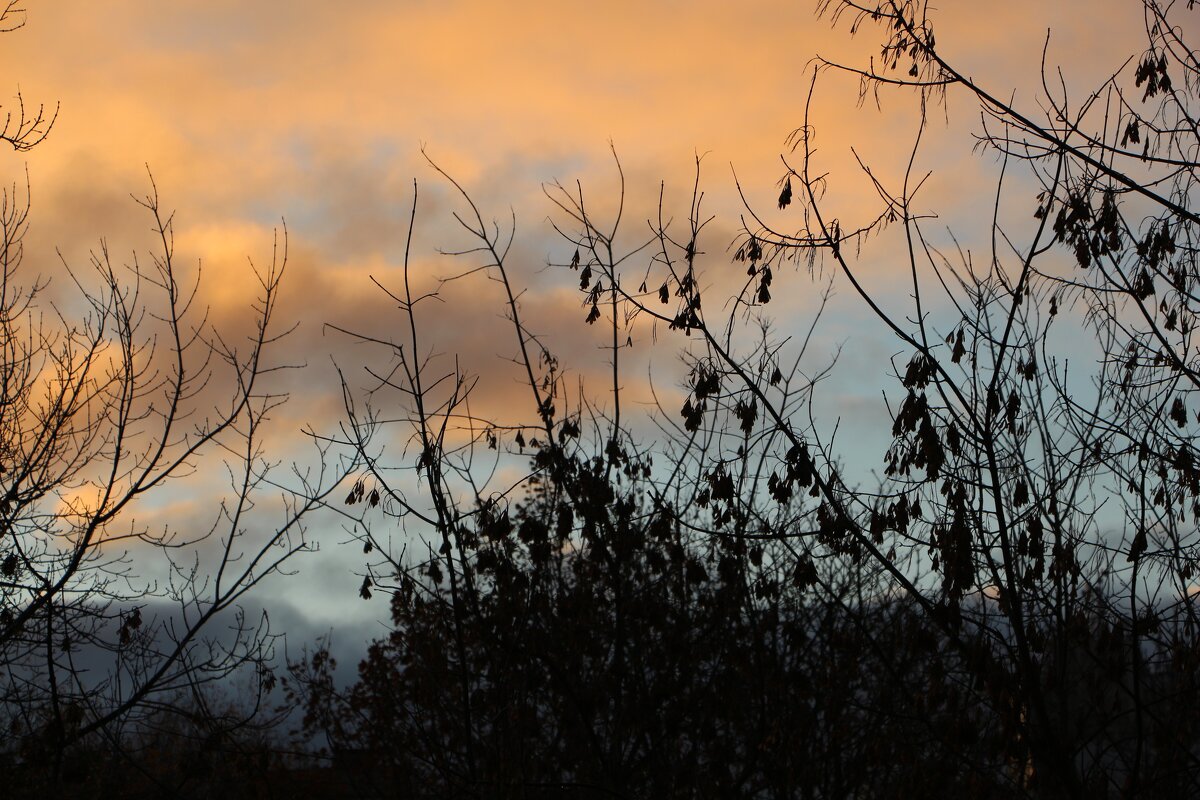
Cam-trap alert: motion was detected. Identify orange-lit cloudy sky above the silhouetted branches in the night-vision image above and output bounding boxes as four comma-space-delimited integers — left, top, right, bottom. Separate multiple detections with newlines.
0, 0, 1161, 671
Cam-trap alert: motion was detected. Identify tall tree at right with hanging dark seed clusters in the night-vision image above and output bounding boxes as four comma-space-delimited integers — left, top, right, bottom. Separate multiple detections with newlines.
520, 1, 1200, 796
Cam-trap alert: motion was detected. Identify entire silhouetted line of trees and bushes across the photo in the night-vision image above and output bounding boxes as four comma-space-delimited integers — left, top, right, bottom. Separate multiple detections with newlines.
0, 0, 1200, 798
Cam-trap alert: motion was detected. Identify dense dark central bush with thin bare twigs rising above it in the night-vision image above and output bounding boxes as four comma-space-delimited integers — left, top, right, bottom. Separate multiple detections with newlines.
289, 154, 1019, 796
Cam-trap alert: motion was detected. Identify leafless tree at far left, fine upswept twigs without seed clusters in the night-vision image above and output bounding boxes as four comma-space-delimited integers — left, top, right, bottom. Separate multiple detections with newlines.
0, 12, 347, 788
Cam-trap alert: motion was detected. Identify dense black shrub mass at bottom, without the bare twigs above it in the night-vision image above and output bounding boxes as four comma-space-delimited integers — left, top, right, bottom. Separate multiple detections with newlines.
285, 456, 1198, 798
